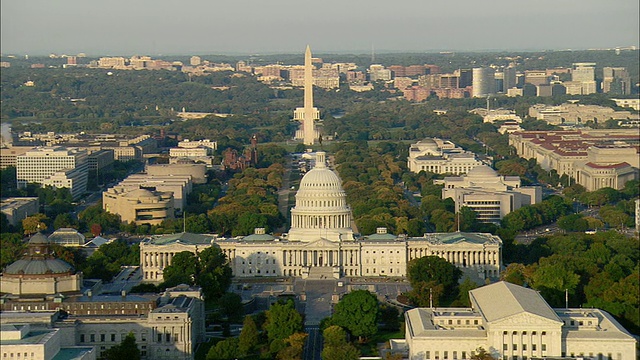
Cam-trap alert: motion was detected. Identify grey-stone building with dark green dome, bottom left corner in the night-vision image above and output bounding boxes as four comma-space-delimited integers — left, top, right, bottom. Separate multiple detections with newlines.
0, 233, 205, 360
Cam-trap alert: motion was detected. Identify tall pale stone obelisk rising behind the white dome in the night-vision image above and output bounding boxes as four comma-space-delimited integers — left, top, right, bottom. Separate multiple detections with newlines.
293, 45, 320, 145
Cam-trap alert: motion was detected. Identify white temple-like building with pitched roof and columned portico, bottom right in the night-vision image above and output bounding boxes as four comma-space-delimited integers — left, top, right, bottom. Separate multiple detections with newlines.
398, 281, 636, 360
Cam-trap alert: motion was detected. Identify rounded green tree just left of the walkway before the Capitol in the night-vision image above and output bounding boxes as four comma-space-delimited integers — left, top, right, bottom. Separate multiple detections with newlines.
264, 300, 303, 343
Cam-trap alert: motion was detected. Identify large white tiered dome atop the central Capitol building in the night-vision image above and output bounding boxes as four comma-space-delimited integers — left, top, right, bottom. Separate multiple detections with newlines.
289, 151, 353, 241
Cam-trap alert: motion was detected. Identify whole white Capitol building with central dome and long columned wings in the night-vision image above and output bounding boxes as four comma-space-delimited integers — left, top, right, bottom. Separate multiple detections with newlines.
140, 152, 502, 283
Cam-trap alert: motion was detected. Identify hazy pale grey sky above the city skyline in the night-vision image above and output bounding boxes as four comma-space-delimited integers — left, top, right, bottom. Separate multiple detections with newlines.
0, 0, 640, 56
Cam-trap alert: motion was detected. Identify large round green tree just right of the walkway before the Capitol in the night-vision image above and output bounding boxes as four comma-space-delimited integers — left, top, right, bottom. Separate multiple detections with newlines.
332, 290, 379, 342
